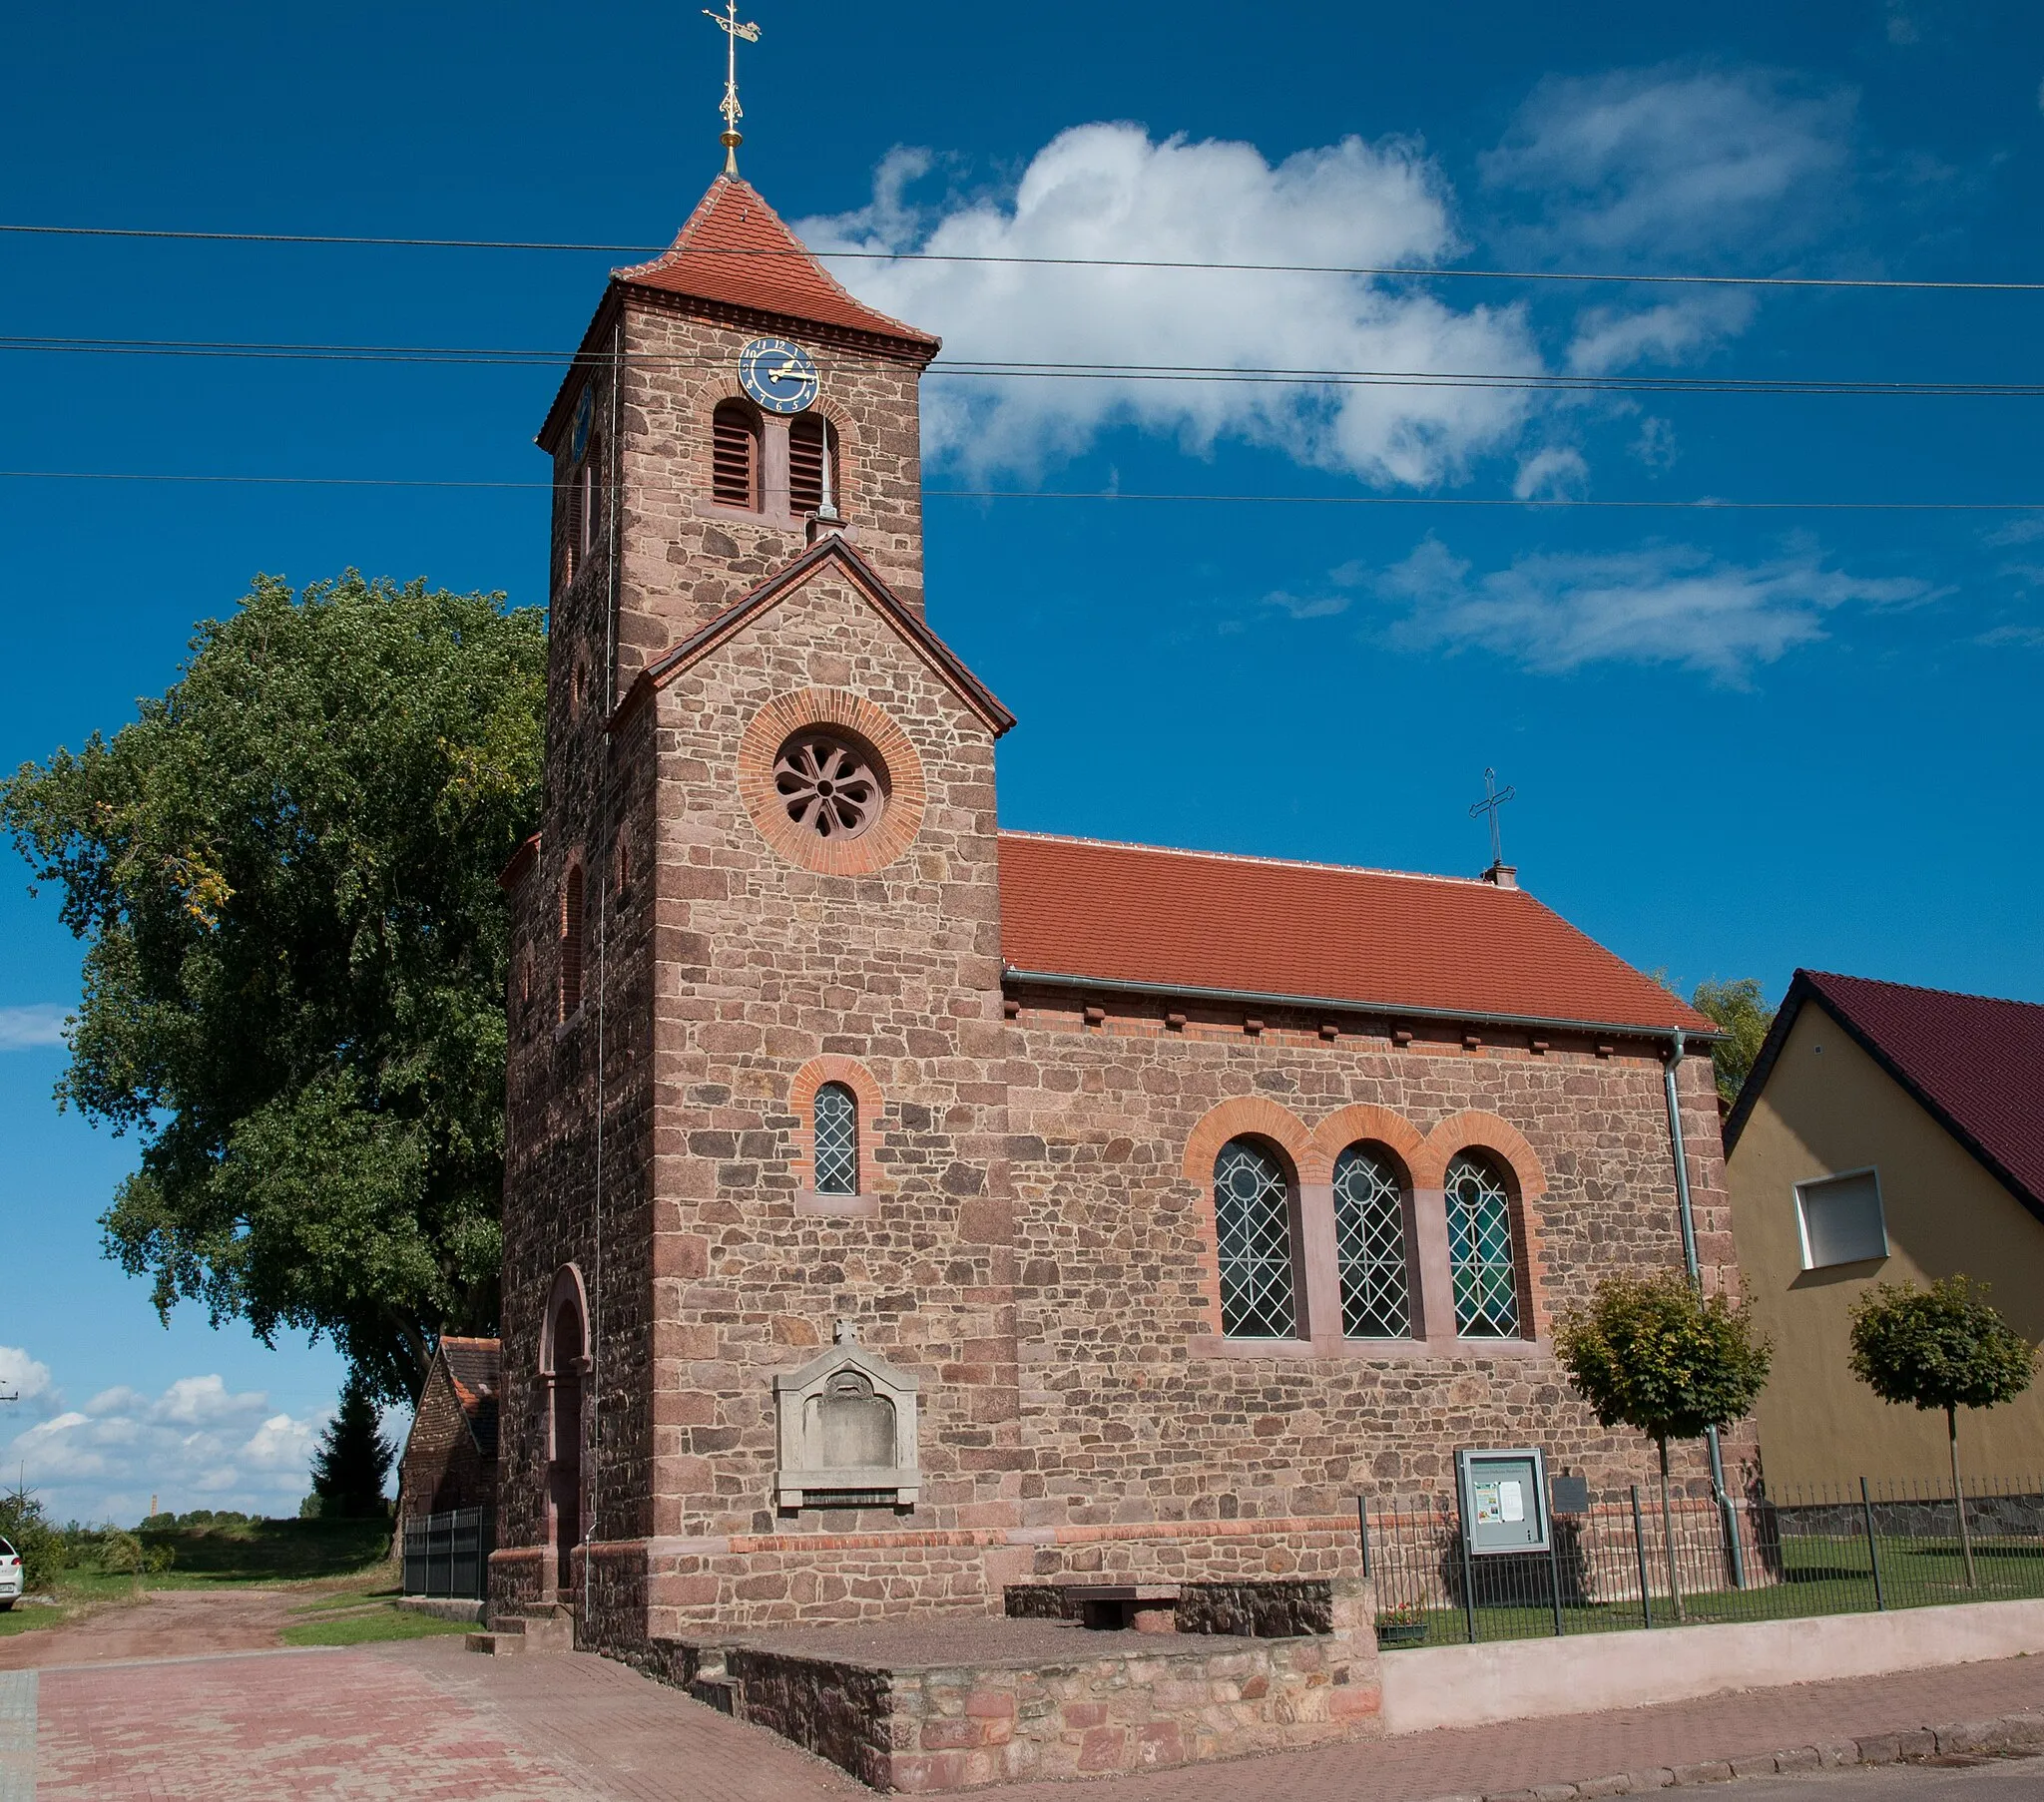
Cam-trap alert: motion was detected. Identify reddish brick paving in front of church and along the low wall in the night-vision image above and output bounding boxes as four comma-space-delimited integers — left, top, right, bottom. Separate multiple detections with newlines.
19, 1638, 2044, 1802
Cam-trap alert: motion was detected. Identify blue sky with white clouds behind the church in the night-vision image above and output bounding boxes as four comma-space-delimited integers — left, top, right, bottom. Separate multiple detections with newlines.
0, 0, 2044, 1516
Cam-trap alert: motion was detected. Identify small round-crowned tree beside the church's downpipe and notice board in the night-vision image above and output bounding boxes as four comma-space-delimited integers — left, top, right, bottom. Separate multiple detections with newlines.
1553, 1271, 1773, 1620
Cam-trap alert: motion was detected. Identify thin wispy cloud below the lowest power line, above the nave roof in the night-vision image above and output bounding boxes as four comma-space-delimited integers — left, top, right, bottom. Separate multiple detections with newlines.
1373, 538, 1931, 684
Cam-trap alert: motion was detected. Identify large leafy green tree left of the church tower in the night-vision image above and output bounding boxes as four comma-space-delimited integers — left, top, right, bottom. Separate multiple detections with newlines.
0, 572, 546, 1400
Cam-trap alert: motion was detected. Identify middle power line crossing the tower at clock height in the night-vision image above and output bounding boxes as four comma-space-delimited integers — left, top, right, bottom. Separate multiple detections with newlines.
0, 335, 2044, 398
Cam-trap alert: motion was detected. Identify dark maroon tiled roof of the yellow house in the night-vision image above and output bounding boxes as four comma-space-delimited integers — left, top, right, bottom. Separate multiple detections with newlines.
1726, 971, 2044, 1219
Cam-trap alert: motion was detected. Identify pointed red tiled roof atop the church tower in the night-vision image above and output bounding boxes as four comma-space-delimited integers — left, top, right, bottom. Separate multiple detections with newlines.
615, 176, 938, 353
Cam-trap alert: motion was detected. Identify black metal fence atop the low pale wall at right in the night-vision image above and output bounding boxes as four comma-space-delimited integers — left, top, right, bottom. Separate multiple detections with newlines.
1359, 1479, 2044, 1648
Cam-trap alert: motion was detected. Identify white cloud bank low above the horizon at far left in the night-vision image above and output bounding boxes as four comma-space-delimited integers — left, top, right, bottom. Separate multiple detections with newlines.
0, 1348, 325, 1525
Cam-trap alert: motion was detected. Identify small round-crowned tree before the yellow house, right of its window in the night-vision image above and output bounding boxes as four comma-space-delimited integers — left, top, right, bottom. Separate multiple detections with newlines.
1851, 1277, 2036, 1589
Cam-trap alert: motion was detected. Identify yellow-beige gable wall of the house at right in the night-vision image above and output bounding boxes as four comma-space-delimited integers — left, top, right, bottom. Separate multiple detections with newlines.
1726, 1001, 2044, 1486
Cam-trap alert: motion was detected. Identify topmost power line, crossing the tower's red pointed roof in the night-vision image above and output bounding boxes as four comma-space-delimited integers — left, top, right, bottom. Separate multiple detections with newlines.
0, 225, 2044, 294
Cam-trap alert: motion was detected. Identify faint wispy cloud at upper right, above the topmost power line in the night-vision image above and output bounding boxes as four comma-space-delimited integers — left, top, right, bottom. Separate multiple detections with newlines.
1482, 68, 1854, 257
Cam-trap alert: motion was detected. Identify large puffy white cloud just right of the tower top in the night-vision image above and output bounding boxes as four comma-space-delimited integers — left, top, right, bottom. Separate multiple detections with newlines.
797, 125, 1541, 486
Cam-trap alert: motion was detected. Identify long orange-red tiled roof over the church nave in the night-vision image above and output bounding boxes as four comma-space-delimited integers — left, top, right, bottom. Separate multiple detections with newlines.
999, 831, 1715, 1034
